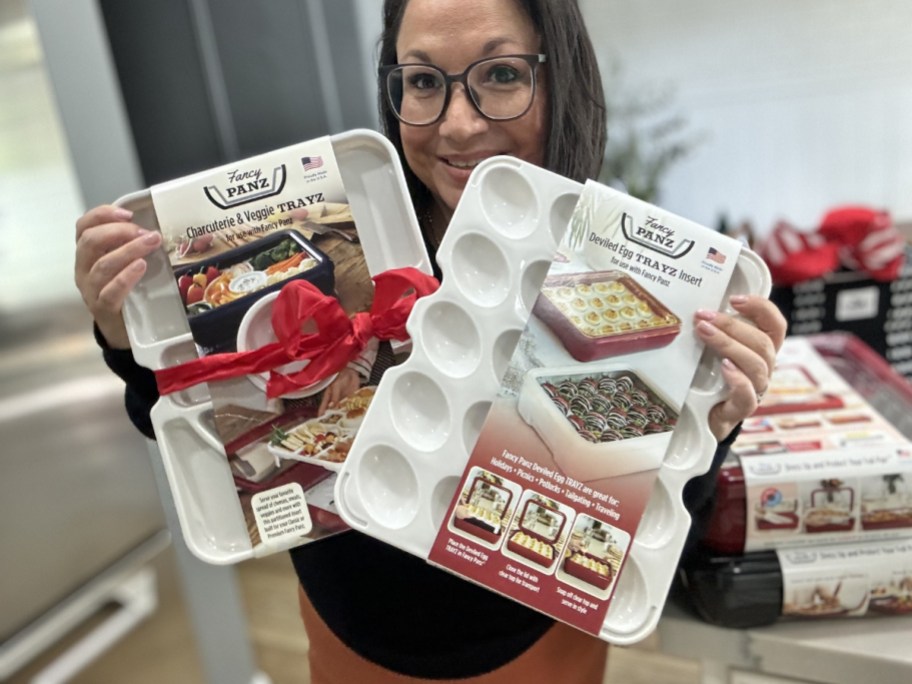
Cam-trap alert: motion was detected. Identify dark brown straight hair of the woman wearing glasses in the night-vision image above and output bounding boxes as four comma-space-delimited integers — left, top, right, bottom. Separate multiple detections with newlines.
377, 0, 606, 224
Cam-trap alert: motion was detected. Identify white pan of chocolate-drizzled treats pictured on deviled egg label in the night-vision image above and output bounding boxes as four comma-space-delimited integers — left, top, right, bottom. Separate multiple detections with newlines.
517, 363, 679, 482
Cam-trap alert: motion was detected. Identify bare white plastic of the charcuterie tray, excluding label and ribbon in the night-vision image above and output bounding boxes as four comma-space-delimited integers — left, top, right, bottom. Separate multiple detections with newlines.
116, 129, 431, 565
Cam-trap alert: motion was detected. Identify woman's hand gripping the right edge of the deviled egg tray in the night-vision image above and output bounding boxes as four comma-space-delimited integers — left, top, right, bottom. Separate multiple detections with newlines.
696, 295, 787, 441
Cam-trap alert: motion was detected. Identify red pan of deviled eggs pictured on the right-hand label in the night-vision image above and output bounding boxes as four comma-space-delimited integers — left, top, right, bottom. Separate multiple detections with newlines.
532, 271, 681, 361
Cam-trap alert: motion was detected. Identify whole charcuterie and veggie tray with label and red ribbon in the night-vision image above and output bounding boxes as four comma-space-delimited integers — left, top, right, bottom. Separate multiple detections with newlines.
118, 131, 437, 563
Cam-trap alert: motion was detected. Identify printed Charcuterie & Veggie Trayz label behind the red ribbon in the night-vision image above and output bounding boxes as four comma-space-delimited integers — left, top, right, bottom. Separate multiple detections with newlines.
152, 138, 376, 554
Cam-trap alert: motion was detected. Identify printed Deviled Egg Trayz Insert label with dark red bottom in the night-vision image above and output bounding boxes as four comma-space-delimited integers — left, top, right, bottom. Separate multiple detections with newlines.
430, 182, 740, 633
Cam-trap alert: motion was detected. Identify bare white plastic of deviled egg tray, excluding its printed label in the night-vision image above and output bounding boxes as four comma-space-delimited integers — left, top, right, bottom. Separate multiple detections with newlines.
336, 157, 771, 644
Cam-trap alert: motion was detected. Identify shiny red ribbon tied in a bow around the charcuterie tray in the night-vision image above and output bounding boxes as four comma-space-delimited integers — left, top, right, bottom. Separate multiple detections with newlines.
155, 268, 439, 398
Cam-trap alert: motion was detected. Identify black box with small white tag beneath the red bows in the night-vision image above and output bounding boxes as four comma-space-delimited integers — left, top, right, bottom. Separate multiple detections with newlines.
770, 247, 912, 378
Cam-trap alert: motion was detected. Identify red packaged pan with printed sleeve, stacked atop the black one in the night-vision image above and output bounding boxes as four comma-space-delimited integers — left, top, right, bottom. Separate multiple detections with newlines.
703, 337, 912, 553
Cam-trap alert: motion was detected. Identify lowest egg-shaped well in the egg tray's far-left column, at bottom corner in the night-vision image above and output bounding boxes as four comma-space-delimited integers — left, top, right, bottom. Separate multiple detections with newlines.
355, 443, 421, 530
